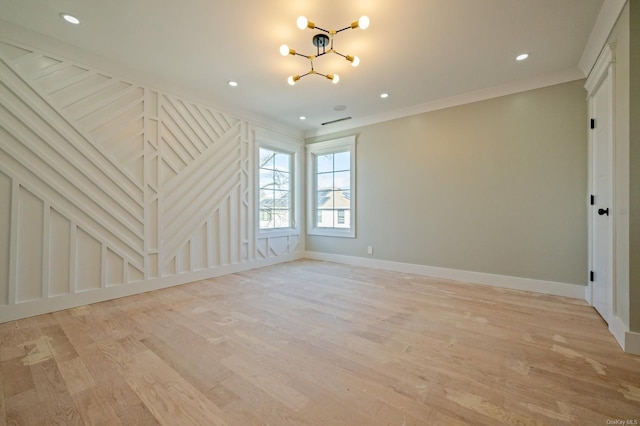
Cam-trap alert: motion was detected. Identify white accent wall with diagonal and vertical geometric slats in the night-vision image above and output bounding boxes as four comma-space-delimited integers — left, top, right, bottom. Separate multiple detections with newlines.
0, 40, 302, 322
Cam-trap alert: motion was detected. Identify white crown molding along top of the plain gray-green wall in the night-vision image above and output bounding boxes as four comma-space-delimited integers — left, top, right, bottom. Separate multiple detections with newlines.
304, 68, 586, 138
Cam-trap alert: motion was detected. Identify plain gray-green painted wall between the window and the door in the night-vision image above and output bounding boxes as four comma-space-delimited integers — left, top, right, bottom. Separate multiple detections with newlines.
306, 81, 587, 285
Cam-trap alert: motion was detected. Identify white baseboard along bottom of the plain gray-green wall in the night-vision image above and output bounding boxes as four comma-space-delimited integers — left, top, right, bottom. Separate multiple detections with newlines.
304, 251, 586, 300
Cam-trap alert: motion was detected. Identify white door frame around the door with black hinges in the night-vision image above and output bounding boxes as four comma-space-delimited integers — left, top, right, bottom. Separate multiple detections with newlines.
584, 43, 617, 326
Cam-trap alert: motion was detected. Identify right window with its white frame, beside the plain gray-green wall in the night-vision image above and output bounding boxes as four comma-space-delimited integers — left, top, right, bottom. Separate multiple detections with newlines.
307, 136, 355, 238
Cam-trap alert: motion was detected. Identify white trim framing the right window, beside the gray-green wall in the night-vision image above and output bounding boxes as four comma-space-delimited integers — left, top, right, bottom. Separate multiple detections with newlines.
307, 135, 357, 238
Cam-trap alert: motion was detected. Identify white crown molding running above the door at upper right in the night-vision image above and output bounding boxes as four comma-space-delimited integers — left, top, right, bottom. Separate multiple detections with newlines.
578, 0, 627, 75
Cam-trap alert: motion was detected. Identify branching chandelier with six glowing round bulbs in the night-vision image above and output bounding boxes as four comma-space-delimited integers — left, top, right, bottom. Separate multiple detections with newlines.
280, 16, 369, 86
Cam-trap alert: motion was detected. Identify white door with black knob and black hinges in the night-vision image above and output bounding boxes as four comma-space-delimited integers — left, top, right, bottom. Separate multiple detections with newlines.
589, 64, 614, 323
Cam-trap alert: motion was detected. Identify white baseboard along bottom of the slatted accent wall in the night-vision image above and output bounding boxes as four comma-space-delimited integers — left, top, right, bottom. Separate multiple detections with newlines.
0, 252, 304, 323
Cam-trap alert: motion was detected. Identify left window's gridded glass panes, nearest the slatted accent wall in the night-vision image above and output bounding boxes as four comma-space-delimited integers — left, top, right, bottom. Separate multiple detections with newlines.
258, 147, 293, 229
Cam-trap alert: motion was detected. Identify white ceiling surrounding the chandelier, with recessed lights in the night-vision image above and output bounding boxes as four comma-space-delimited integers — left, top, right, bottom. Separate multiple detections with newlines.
0, 0, 603, 134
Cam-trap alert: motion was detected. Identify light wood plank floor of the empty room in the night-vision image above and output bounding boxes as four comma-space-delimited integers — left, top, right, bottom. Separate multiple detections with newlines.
0, 260, 640, 426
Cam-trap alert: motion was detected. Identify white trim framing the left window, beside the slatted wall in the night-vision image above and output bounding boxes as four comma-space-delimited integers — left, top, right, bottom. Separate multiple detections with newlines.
253, 130, 303, 238
